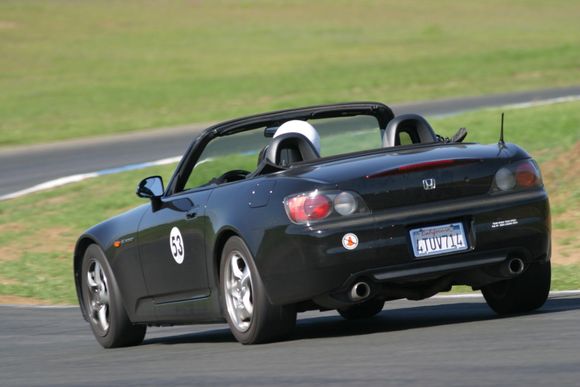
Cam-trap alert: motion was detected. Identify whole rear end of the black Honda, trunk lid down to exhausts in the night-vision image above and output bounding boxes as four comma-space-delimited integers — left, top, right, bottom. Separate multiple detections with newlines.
257, 144, 550, 308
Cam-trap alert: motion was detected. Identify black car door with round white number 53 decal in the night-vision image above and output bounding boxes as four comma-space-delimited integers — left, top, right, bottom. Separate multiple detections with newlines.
139, 190, 211, 304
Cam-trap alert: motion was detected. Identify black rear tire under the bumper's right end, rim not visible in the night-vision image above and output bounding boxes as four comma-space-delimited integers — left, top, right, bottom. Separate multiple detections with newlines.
481, 261, 552, 315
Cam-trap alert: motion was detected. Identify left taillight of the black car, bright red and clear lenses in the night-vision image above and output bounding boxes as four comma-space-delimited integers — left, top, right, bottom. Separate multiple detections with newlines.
284, 190, 368, 224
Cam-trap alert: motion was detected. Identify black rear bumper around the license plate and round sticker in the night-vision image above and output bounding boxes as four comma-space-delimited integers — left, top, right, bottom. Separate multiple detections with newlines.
256, 189, 550, 307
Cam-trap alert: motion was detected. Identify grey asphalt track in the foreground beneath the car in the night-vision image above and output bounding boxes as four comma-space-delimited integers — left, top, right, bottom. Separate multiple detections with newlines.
0, 293, 580, 387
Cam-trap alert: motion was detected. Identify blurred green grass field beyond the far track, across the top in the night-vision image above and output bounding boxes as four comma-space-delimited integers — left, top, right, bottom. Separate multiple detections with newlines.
0, 0, 580, 147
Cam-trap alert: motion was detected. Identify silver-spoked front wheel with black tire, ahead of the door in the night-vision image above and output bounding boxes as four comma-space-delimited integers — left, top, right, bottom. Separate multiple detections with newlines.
81, 244, 147, 348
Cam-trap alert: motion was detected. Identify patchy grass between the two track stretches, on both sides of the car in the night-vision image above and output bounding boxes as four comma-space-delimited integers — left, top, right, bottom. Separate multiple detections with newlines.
0, 103, 580, 303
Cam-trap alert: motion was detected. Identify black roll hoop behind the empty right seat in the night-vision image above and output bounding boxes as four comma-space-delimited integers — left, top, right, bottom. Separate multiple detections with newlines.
383, 114, 437, 148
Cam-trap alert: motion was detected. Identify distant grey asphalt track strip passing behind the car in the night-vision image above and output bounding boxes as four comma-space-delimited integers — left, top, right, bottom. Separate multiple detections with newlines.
0, 86, 580, 197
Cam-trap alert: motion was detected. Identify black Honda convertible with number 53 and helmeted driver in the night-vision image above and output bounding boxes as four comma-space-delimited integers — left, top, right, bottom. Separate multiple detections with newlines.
74, 102, 551, 347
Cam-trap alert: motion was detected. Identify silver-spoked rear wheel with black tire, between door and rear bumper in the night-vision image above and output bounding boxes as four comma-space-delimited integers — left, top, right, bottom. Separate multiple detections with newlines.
220, 236, 296, 344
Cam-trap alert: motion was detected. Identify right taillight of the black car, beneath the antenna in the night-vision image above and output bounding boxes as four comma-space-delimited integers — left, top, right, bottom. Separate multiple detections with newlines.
494, 160, 543, 191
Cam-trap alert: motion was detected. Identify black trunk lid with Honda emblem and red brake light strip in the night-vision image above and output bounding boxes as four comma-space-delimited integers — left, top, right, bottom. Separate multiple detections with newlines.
286, 144, 529, 211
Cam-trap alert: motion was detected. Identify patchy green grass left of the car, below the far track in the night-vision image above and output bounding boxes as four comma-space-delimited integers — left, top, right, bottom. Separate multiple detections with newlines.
0, 162, 174, 304
